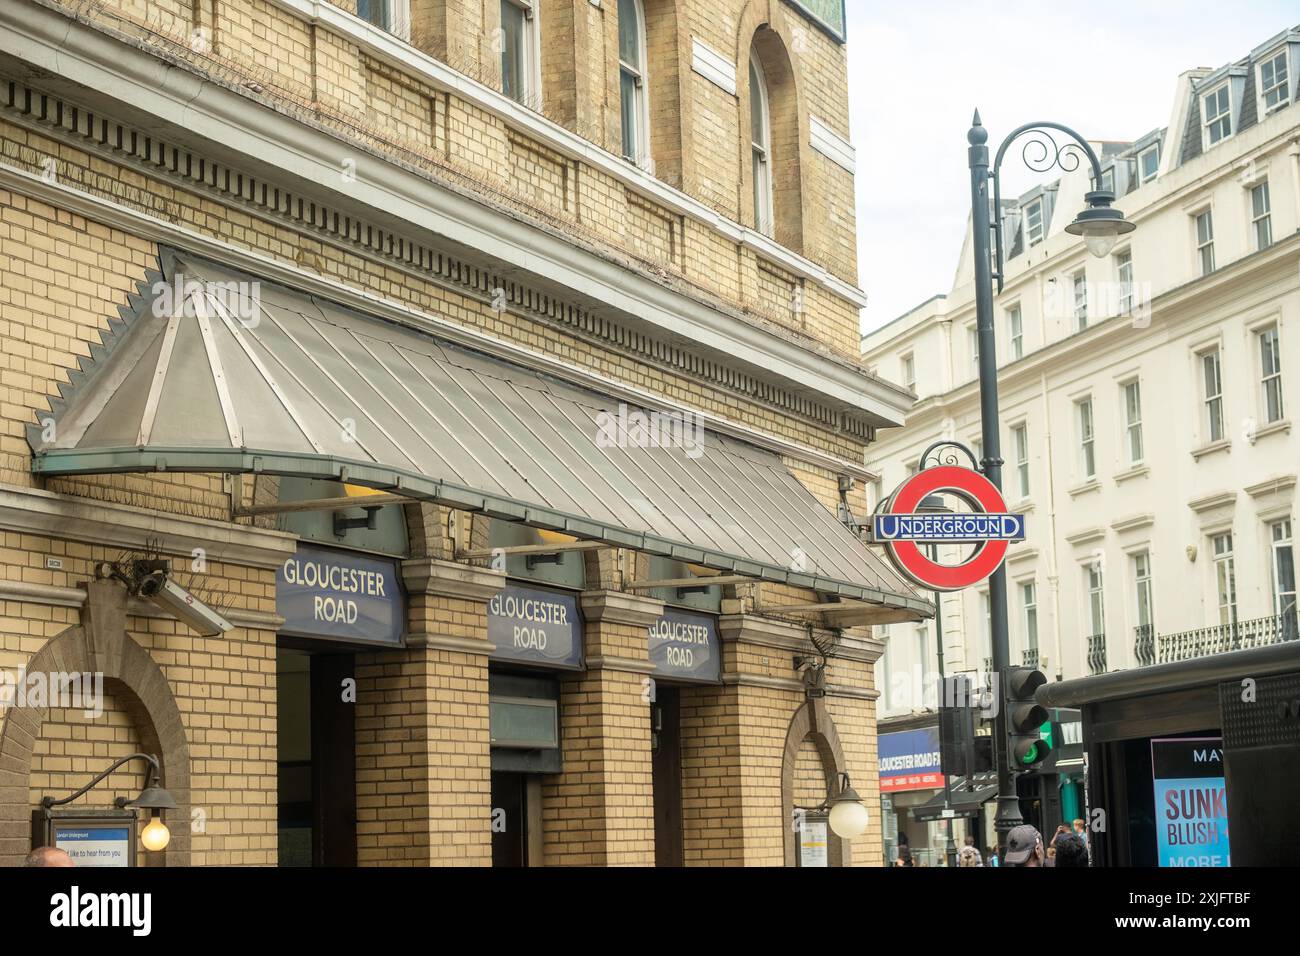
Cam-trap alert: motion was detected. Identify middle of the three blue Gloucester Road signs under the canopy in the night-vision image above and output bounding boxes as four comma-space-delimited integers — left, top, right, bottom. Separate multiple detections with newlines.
488, 584, 582, 670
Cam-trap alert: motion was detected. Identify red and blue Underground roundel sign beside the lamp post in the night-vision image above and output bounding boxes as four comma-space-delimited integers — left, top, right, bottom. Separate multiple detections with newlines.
871, 464, 1024, 591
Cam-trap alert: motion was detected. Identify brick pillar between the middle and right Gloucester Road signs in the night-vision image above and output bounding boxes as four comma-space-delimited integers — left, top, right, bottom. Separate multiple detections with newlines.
542, 591, 663, 866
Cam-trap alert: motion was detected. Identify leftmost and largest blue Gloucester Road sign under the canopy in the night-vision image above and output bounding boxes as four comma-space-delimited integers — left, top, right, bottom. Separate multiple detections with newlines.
276, 544, 406, 648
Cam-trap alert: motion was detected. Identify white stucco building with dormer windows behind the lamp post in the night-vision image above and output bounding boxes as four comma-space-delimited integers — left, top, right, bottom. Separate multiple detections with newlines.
863, 22, 1300, 730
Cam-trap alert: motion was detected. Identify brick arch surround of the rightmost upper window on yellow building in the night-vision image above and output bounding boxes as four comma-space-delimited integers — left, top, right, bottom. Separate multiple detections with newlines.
736, 0, 811, 252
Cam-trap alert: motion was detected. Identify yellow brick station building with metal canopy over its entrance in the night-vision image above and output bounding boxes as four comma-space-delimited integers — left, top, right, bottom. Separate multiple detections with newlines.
0, 0, 931, 865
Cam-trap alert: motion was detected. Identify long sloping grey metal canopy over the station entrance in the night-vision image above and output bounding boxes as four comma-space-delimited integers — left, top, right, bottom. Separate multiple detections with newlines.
27, 252, 932, 619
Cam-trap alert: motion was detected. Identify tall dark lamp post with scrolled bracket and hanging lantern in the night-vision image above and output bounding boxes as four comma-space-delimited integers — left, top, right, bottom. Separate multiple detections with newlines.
966, 109, 1135, 849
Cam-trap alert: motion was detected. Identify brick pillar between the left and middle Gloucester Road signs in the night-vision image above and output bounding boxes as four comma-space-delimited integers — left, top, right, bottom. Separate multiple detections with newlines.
356, 558, 504, 866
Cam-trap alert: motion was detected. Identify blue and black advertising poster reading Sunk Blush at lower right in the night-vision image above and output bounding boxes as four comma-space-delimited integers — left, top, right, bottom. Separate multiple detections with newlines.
1151, 737, 1232, 866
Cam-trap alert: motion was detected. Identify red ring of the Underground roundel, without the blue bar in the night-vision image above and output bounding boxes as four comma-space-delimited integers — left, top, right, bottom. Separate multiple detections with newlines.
885, 464, 1010, 591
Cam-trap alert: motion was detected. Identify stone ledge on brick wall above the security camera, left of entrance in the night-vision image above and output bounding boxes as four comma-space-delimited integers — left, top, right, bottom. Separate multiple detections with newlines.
0, 484, 298, 568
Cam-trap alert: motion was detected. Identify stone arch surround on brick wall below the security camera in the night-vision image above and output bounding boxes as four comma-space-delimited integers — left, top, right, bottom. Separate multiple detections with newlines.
0, 580, 190, 866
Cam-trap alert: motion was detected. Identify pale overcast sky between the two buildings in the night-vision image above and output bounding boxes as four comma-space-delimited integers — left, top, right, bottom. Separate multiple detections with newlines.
848, 0, 1300, 330
